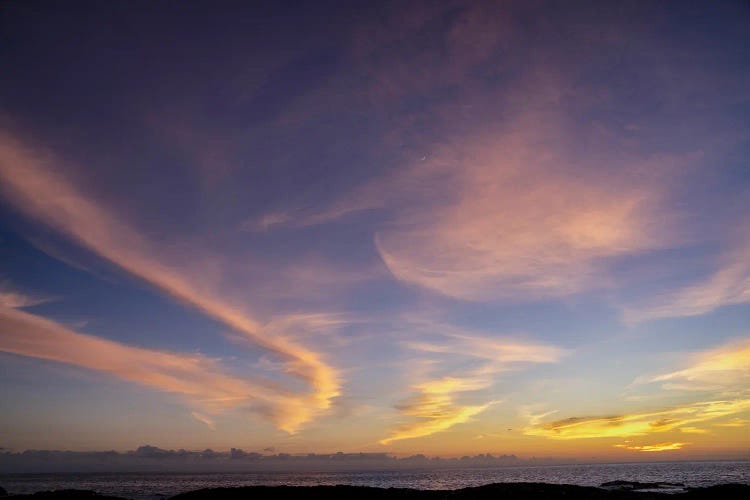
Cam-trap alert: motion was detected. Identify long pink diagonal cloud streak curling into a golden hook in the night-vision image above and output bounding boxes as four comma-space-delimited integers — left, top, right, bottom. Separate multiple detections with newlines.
0, 132, 341, 432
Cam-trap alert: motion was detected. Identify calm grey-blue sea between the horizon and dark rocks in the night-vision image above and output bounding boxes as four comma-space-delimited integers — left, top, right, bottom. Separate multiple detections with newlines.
0, 462, 750, 500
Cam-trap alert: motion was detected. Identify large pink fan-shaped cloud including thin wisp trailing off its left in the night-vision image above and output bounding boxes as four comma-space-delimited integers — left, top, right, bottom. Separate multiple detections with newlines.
274, 100, 680, 301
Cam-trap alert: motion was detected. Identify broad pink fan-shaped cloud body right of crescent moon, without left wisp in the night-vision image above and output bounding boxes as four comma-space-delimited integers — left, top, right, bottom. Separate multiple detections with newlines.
376, 122, 674, 301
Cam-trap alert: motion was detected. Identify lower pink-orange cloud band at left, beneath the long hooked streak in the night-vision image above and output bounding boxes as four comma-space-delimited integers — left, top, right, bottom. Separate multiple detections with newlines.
0, 306, 293, 413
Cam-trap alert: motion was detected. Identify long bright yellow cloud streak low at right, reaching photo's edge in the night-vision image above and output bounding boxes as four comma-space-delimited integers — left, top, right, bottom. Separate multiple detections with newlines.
524, 399, 750, 439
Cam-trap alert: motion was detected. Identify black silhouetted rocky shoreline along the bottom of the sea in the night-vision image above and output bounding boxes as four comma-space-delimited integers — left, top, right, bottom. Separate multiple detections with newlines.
0, 481, 750, 500
